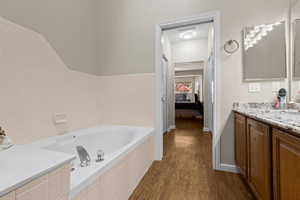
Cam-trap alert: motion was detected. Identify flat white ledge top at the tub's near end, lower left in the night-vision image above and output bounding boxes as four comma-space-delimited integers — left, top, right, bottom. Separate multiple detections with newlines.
0, 144, 75, 197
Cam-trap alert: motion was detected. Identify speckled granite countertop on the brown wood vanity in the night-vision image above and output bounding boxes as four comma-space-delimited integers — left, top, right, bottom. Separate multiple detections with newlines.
233, 103, 300, 136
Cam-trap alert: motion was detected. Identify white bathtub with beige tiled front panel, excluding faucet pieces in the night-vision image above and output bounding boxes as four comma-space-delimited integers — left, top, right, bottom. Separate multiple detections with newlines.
33, 126, 155, 200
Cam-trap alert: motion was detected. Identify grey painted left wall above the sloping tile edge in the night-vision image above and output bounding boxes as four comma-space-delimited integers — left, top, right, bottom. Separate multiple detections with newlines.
0, 0, 98, 73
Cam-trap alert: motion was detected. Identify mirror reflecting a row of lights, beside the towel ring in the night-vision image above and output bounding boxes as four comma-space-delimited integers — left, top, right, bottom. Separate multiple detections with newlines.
242, 21, 287, 82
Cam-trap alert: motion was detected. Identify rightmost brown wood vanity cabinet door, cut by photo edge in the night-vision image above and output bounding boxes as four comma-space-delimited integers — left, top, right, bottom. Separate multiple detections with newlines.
273, 129, 300, 200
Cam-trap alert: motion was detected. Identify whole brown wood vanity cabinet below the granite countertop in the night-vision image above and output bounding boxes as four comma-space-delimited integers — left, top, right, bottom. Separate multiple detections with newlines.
234, 113, 300, 200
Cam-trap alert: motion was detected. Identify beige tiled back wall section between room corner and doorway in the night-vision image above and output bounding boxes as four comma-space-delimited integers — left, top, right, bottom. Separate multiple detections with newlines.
98, 74, 155, 127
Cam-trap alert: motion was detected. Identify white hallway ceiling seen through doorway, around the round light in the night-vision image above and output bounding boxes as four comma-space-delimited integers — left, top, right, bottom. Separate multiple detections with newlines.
164, 23, 211, 43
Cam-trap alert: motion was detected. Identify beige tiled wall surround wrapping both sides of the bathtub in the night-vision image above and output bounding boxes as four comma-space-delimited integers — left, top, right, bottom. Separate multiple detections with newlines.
0, 18, 154, 144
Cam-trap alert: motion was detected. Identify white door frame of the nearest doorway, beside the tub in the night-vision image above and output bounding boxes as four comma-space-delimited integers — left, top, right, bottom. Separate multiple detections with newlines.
155, 11, 221, 170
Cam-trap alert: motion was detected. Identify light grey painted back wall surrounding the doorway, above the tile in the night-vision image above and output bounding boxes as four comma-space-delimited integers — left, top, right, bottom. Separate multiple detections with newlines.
98, 0, 288, 164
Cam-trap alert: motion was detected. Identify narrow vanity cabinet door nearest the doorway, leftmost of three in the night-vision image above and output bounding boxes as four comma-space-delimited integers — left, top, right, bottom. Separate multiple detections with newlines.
234, 113, 247, 179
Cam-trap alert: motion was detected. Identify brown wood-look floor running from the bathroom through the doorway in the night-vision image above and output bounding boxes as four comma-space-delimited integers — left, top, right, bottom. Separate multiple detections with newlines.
130, 119, 253, 200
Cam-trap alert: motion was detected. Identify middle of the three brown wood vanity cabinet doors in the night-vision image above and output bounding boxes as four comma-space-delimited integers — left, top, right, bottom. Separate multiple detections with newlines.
247, 119, 272, 200
